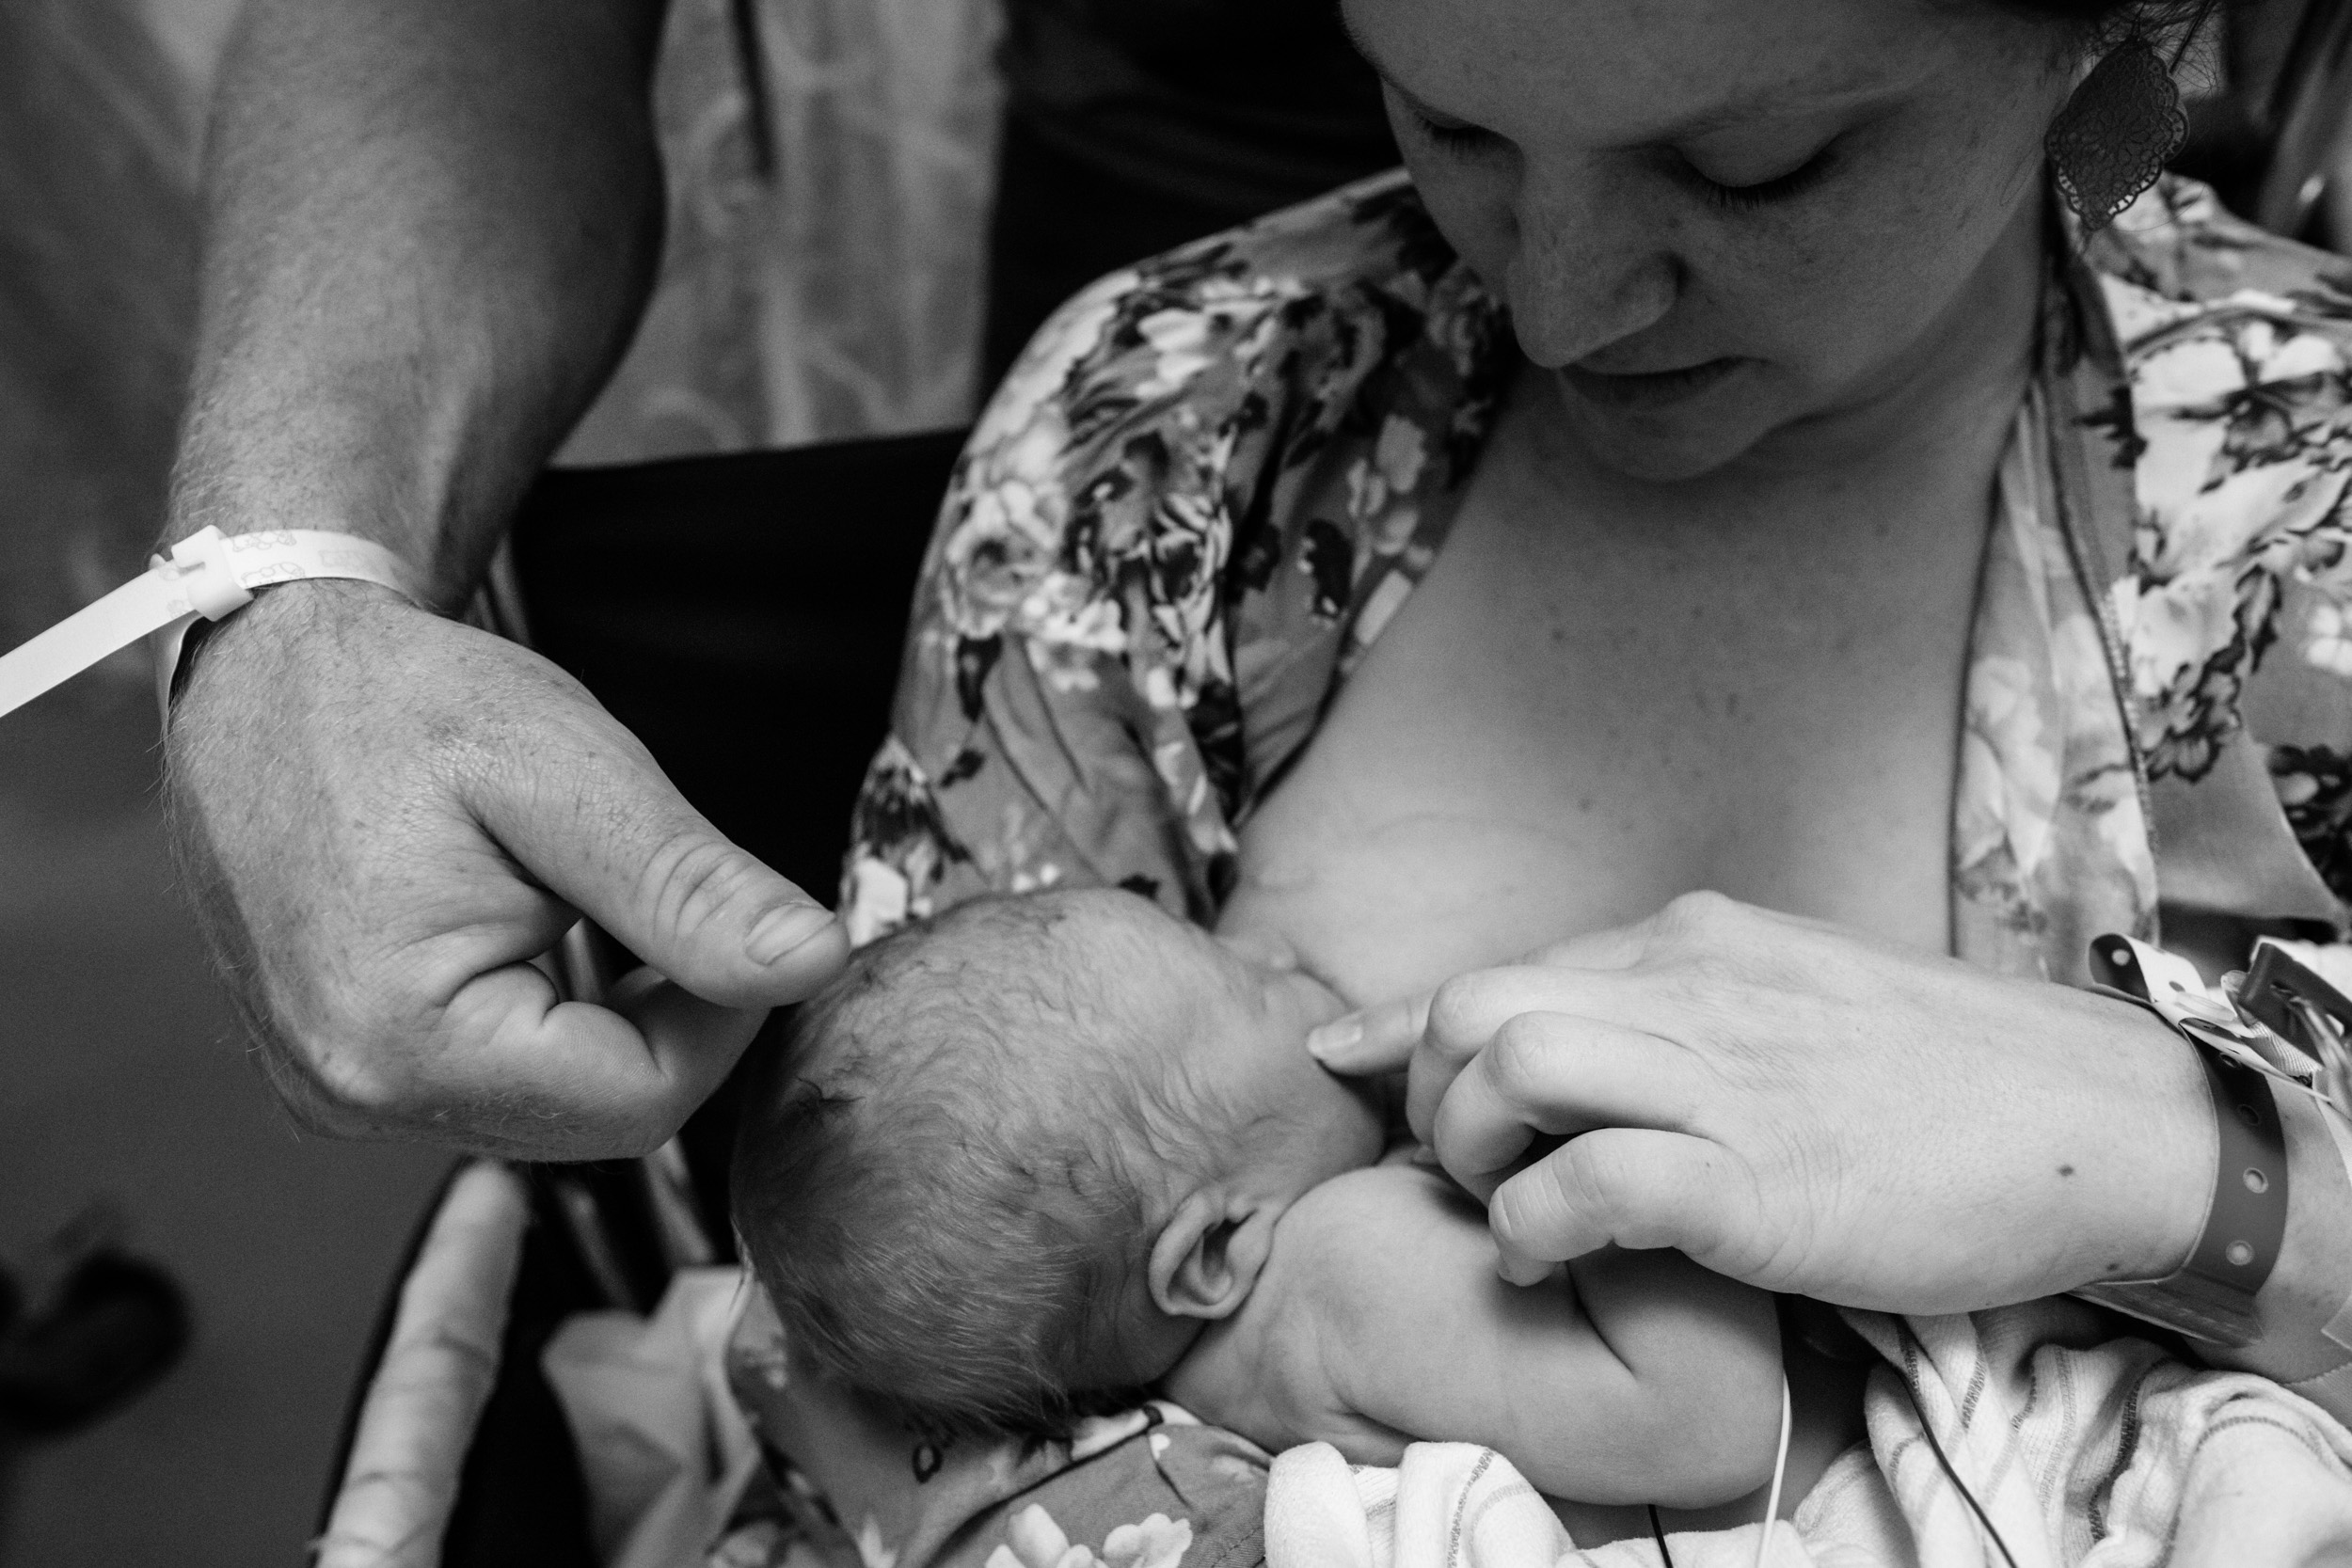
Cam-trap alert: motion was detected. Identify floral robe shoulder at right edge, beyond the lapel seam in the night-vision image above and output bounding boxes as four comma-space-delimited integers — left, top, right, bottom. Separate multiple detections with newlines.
2103, 181, 2352, 917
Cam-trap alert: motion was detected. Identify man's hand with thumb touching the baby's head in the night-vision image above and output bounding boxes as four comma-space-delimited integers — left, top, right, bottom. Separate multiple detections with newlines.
167, 583, 847, 1159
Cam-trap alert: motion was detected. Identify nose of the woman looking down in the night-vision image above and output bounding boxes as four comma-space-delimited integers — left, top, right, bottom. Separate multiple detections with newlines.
1508, 174, 1682, 369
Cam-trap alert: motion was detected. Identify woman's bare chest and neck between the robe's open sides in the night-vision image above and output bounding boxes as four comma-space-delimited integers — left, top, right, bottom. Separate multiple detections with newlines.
1226, 425, 1988, 999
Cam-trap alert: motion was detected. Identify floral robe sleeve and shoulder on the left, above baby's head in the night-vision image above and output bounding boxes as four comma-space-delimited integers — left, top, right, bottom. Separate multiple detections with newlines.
842, 176, 1513, 941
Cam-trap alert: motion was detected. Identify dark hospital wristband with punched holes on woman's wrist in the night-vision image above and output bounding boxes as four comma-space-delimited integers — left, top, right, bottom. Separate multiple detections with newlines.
2074, 936, 2286, 1347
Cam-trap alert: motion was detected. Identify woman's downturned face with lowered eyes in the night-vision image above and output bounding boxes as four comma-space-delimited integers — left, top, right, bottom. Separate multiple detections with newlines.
1343, 0, 2073, 480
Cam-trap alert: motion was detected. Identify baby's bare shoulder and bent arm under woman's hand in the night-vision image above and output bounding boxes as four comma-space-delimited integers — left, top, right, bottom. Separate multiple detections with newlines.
1174, 1166, 1781, 1507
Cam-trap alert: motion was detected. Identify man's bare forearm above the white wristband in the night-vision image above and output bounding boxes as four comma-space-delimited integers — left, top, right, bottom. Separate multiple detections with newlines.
169, 0, 663, 604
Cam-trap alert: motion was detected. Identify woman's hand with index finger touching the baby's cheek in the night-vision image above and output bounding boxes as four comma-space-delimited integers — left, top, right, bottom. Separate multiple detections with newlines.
1312, 894, 2214, 1312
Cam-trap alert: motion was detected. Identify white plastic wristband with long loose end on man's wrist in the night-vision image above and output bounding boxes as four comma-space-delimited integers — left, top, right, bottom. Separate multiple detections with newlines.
0, 529, 419, 715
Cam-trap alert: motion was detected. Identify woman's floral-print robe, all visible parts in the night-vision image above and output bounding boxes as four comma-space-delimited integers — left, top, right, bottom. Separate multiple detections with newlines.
724, 174, 2352, 1568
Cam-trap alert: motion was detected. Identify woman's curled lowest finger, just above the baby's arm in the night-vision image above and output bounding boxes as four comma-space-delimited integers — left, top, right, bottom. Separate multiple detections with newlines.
1486, 1129, 1759, 1284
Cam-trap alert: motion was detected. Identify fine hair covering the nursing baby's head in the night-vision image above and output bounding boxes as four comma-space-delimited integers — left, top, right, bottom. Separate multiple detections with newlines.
734, 894, 1195, 1436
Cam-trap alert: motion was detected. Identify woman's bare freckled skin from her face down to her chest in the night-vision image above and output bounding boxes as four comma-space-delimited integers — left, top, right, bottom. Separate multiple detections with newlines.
1232, 0, 2068, 1002
